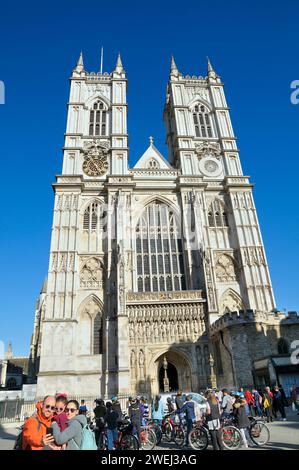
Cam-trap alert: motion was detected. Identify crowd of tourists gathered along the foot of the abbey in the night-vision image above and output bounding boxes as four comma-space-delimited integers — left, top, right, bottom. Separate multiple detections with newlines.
15, 386, 299, 450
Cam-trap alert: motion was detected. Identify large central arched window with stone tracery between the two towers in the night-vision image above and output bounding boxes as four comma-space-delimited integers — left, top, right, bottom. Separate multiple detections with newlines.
136, 202, 186, 292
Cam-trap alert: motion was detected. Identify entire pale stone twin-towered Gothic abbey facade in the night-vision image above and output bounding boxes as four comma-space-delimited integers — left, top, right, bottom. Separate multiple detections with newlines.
31, 55, 288, 396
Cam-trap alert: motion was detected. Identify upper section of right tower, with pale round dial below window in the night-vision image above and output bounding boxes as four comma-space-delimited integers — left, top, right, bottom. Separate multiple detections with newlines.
164, 57, 242, 179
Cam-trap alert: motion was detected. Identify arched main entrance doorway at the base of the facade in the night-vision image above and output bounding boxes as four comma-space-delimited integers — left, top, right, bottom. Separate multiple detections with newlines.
154, 350, 196, 395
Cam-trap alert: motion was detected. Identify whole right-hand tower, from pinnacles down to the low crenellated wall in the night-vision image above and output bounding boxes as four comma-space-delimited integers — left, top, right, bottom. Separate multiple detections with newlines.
164, 57, 275, 322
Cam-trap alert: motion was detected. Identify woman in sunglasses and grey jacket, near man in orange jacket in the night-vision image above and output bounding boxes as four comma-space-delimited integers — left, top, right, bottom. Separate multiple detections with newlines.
52, 400, 87, 450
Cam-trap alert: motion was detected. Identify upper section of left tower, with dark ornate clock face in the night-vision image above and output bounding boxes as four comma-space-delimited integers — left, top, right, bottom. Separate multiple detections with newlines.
62, 52, 128, 176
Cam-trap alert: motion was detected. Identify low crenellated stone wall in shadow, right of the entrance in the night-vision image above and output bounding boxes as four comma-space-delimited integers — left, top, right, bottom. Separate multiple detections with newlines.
210, 310, 299, 388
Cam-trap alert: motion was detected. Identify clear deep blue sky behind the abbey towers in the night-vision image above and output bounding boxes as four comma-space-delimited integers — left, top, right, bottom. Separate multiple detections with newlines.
0, 0, 299, 354
